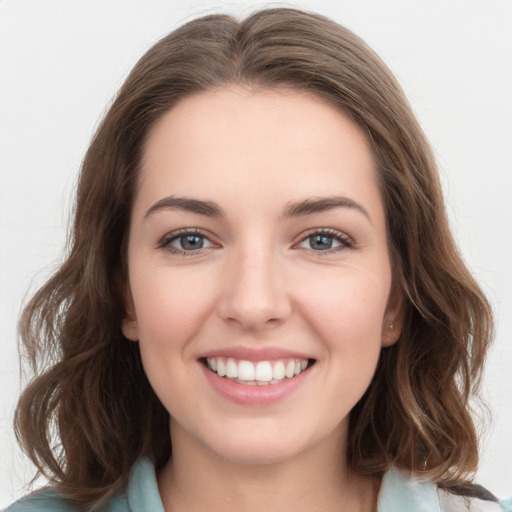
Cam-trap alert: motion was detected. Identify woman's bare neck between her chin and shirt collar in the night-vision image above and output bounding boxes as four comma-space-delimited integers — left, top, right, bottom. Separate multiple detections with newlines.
158, 425, 379, 512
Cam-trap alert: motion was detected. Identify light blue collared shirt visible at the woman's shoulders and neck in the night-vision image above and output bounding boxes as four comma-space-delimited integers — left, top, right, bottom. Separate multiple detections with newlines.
4, 459, 512, 512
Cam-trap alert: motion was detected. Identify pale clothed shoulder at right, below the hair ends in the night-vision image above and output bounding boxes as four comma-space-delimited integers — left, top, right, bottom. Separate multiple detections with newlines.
378, 468, 512, 512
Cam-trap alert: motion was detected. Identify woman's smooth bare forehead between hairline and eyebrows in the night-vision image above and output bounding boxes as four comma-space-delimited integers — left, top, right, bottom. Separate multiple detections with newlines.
138, 87, 381, 224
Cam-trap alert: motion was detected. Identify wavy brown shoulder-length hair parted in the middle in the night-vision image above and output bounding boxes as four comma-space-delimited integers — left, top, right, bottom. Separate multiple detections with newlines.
15, 9, 492, 508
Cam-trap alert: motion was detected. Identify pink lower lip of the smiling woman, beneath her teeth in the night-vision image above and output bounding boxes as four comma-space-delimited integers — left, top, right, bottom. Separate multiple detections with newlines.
200, 363, 311, 405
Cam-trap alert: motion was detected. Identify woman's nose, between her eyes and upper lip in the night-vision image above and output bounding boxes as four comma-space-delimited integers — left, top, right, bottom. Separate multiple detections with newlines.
218, 247, 292, 331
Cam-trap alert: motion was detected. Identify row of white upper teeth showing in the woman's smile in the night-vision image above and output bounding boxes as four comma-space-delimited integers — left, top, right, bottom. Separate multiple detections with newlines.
206, 357, 308, 384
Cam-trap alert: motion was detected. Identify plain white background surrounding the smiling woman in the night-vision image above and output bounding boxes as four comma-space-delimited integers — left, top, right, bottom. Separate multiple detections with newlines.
0, 0, 512, 507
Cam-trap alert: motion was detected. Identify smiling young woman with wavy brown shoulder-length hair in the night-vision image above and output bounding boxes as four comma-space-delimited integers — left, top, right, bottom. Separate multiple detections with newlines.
4, 9, 503, 512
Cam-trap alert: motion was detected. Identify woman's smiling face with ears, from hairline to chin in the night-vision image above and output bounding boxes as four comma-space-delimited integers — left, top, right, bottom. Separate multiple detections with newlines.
123, 87, 400, 463
